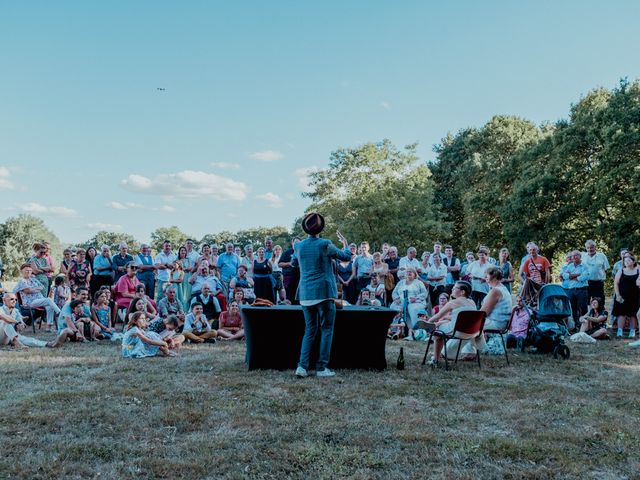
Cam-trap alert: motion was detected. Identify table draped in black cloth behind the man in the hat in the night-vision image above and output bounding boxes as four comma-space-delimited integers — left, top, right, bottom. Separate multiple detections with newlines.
241, 305, 396, 370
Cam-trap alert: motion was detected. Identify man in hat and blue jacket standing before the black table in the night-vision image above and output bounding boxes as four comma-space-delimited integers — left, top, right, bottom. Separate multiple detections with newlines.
291, 213, 351, 378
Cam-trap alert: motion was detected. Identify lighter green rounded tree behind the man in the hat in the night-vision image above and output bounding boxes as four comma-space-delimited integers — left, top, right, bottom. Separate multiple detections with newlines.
305, 140, 449, 249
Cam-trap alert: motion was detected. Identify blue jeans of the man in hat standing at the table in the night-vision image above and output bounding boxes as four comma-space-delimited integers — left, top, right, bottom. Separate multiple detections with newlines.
298, 300, 336, 371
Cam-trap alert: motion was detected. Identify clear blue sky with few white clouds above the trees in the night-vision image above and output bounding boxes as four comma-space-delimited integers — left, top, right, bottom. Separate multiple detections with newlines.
0, 0, 640, 243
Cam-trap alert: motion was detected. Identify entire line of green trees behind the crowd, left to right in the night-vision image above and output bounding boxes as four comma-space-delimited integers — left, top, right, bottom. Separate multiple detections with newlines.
0, 79, 640, 275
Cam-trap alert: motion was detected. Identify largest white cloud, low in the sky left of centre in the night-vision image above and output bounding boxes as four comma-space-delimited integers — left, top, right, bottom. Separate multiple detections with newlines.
120, 170, 249, 200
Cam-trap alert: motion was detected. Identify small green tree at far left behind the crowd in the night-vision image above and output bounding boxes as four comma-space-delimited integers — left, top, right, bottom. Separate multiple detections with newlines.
0, 214, 62, 278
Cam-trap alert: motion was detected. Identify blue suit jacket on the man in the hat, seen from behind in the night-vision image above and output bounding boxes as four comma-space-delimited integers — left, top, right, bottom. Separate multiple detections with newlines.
291, 237, 351, 301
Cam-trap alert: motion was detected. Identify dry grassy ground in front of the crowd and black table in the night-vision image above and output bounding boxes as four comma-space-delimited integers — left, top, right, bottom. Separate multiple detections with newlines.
0, 332, 640, 479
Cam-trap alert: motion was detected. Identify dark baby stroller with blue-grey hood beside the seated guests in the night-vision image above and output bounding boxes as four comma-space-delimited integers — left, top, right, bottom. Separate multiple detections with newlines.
527, 284, 572, 360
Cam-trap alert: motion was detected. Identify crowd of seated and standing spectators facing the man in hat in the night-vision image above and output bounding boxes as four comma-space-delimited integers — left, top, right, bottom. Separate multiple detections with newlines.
0, 237, 640, 362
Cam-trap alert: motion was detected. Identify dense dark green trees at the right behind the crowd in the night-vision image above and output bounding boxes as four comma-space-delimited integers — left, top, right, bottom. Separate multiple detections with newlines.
432, 80, 640, 257
